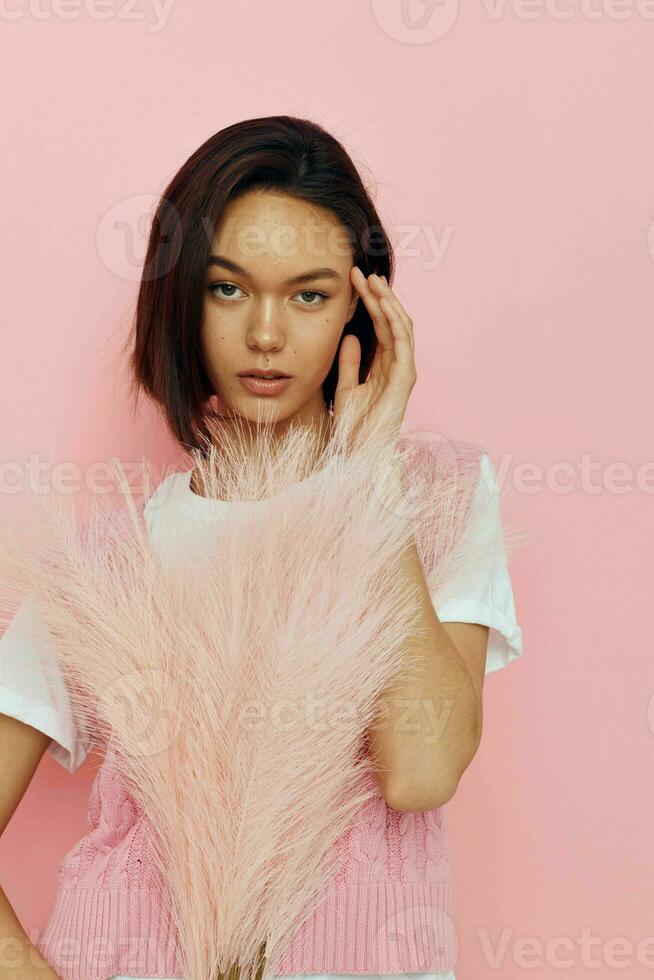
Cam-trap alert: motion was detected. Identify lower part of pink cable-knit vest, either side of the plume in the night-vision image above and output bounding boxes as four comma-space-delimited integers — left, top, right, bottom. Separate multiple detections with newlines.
36, 753, 456, 980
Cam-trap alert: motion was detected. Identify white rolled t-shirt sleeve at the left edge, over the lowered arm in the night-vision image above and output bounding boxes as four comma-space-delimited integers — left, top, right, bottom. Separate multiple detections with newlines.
0, 594, 93, 772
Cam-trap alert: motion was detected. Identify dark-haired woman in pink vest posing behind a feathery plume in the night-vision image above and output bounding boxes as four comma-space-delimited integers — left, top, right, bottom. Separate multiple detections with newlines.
0, 116, 522, 980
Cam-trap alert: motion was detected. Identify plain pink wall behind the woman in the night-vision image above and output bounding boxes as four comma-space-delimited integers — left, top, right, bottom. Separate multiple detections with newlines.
0, 0, 654, 980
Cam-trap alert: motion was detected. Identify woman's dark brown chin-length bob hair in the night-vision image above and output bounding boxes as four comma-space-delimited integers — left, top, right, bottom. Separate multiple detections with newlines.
128, 116, 394, 450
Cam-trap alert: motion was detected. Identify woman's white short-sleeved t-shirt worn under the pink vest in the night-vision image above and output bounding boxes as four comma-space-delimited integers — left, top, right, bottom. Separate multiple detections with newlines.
0, 453, 522, 980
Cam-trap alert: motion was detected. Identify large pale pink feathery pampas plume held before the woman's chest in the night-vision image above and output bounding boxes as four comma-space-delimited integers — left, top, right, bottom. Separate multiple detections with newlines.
0, 398, 524, 980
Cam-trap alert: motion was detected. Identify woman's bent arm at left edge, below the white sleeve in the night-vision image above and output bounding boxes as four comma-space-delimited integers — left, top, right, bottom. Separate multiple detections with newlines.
0, 713, 58, 980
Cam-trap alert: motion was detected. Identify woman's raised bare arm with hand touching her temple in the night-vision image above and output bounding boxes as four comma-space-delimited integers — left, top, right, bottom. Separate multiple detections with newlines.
334, 274, 488, 810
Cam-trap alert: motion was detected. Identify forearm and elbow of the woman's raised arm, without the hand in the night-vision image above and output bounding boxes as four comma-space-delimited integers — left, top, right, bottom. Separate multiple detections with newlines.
368, 539, 488, 810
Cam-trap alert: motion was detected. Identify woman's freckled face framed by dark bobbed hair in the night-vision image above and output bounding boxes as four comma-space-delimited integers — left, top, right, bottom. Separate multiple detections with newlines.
201, 190, 357, 429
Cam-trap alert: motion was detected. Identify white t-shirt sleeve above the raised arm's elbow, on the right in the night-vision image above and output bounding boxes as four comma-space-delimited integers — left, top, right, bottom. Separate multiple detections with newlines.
434, 453, 522, 674
